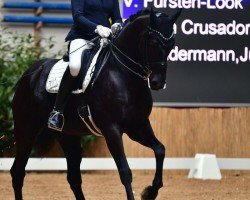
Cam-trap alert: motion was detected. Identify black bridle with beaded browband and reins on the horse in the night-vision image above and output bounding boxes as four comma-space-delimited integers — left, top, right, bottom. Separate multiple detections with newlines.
110, 26, 174, 80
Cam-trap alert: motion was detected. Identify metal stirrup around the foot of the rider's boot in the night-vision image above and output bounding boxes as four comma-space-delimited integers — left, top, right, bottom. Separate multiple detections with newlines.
48, 110, 64, 132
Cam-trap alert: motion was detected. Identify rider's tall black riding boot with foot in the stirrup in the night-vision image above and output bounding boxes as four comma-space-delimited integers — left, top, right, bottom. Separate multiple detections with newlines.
48, 67, 76, 131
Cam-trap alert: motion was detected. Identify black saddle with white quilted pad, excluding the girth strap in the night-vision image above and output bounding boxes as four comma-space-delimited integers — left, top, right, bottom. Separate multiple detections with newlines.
46, 40, 110, 94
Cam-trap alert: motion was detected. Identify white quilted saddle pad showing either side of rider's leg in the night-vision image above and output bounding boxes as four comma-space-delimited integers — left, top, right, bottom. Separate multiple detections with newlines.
46, 39, 105, 94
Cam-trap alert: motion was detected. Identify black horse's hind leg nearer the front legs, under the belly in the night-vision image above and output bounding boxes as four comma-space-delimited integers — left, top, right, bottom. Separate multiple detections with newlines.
59, 135, 85, 200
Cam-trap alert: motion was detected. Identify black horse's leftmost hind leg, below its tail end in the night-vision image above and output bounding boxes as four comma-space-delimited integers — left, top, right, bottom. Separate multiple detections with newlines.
10, 128, 35, 200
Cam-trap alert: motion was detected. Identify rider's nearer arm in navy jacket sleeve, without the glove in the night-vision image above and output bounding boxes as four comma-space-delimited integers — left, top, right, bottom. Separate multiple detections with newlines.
71, 0, 97, 33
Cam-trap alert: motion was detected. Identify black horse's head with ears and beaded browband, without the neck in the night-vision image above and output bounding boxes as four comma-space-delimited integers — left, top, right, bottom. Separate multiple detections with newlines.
145, 9, 181, 90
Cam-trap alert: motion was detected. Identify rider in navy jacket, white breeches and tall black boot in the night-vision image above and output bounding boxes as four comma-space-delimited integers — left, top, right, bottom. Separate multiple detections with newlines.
48, 0, 122, 131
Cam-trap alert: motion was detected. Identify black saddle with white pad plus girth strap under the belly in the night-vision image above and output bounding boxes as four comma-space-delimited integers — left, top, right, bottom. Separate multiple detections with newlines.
46, 39, 110, 136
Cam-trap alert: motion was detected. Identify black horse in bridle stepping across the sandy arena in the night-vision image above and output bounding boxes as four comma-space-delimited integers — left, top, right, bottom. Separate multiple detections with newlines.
11, 10, 181, 200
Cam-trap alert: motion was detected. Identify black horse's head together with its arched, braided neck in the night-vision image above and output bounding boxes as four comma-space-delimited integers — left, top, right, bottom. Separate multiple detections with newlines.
111, 9, 181, 90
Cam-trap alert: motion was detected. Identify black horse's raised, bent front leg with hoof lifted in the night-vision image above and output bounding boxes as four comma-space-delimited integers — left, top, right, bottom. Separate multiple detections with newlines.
127, 120, 165, 200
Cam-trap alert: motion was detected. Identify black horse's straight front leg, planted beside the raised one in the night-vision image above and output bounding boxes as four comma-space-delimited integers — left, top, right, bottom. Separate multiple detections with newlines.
103, 127, 134, 200
